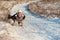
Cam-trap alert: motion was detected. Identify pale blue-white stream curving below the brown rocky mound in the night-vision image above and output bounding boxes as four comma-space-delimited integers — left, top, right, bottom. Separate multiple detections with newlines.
0, 4, 60, 40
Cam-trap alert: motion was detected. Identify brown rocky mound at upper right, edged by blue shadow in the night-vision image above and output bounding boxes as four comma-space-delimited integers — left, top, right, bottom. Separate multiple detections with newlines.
29, 0, 60, 18
